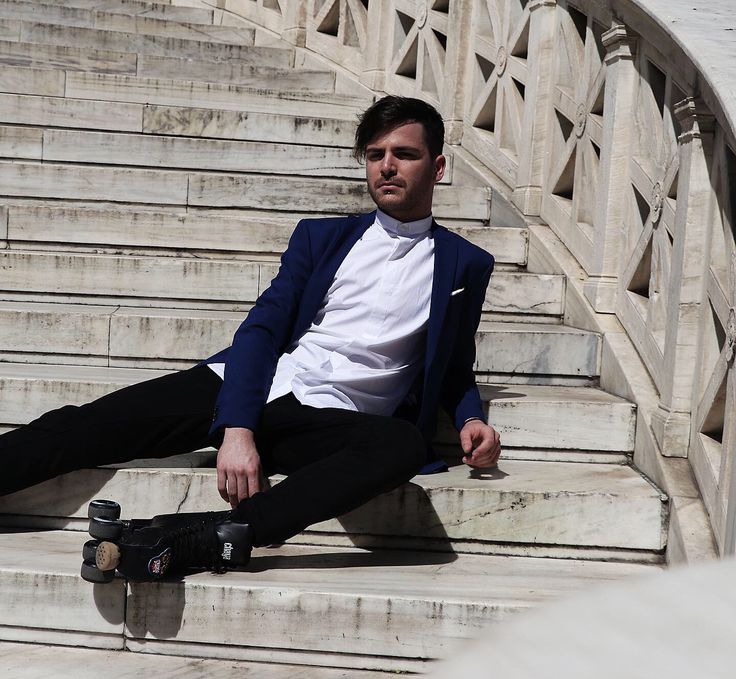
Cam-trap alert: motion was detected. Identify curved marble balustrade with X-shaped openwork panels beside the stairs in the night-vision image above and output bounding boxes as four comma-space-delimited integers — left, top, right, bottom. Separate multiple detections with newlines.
212, 0, 736, 554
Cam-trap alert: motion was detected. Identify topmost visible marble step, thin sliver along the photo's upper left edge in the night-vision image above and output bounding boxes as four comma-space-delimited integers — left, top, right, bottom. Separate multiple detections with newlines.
12, 0, 218, 24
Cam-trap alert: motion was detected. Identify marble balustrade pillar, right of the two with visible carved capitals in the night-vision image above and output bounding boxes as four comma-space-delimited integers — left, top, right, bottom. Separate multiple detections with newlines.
652, 97, 714, 457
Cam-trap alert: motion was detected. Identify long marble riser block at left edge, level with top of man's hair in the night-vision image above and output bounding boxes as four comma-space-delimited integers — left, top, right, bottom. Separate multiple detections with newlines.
0, 92, 143, 132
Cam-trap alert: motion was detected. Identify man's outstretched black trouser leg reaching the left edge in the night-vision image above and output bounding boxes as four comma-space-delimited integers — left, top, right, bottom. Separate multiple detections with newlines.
0, 366, 222, 495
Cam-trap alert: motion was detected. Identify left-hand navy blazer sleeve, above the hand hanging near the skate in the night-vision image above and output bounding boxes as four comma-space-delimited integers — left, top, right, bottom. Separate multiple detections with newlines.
210, 221, 313, 431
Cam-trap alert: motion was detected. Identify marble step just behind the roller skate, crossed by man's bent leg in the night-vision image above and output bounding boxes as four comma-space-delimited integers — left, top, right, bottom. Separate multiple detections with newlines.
0, 458, 667, 560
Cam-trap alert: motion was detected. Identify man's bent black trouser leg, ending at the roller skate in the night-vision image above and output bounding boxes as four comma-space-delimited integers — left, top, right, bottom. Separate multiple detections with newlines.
233, 395, 426, 545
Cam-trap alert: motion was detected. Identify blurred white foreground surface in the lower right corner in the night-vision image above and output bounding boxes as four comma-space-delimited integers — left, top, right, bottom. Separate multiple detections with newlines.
429, 559, 736, 679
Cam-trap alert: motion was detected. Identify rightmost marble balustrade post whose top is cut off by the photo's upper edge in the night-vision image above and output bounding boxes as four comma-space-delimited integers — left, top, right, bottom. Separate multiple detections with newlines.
512, 0, 557, 217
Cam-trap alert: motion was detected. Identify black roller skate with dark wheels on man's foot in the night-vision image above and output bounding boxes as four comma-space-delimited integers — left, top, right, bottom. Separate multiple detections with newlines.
81, 500, 253, 583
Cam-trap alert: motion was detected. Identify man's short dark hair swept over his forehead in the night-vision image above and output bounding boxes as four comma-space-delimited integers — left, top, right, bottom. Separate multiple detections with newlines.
353, 95, 445, 162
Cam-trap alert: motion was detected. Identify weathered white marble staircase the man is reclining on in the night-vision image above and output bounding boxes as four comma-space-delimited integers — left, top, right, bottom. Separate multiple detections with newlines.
0, 0, 668, 677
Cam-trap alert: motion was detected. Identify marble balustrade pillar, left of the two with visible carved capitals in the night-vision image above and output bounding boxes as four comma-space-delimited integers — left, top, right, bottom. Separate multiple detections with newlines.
584, 24, 637, 313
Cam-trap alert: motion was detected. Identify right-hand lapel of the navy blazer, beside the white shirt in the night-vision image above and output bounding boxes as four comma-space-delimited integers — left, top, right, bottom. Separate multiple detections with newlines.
424, 222, 457, 385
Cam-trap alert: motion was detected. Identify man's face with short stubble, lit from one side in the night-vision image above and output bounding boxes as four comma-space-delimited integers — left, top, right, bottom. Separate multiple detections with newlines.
365, 123, 445, 222
